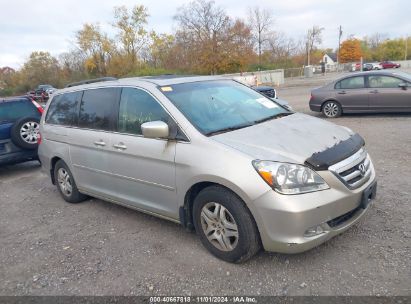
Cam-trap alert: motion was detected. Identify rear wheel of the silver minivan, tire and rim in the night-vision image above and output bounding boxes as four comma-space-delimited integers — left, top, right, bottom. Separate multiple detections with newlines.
54, 160, 87, 204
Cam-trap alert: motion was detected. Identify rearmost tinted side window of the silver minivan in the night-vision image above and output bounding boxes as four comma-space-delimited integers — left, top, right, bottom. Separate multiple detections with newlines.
46, 92, 83, 126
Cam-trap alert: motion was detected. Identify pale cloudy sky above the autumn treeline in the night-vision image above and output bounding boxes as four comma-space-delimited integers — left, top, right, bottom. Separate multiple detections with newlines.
0, 0, 411, 69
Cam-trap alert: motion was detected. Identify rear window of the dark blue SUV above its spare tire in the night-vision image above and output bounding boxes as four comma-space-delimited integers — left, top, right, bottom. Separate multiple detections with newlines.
0, 99, 40, 122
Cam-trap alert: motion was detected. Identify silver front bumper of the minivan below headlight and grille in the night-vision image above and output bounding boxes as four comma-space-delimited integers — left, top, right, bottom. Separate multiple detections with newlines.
254, 171, 376, 253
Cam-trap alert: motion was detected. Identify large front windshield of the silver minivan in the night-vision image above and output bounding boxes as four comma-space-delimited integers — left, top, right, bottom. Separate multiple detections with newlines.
160, 80, 291, 135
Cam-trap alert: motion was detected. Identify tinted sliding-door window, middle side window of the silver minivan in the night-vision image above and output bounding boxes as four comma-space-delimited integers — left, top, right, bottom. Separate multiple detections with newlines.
79, 88, 121, 130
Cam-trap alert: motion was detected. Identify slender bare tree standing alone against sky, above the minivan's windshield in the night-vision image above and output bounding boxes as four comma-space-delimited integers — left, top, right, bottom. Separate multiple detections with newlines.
248, 6, 274, 65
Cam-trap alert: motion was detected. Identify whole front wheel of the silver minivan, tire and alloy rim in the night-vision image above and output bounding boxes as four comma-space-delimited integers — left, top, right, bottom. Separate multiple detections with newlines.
193, 186, 260, 263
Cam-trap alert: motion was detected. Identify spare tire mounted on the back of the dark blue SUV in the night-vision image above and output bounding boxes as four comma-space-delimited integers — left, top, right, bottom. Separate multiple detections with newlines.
10, 117, 40, 150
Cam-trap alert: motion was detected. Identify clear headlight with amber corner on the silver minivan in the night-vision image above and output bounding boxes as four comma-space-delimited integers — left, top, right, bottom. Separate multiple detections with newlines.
253, 160, 329, 194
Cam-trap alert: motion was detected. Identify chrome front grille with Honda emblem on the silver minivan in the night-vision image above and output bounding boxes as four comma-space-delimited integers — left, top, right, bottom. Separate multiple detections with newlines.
328, 148, 373, 189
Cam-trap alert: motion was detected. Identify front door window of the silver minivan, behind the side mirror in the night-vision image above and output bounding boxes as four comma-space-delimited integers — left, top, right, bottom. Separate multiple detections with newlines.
118, 88, 169, 135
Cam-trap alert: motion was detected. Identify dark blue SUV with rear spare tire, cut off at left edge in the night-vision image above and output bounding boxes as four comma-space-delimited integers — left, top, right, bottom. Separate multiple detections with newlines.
0, 96, 43, 166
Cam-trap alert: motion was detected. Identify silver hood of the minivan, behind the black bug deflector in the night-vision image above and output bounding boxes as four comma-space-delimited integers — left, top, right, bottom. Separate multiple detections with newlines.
211, 113, 353, 164
